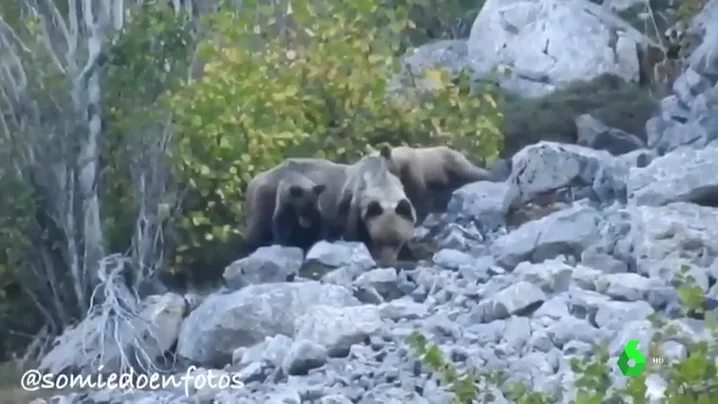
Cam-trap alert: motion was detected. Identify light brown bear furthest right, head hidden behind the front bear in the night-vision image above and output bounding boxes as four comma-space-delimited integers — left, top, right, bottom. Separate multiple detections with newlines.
375, 146, 491, 221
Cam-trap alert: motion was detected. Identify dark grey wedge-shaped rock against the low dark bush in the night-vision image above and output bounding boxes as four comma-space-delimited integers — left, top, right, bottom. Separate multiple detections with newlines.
576, 114, 645, 156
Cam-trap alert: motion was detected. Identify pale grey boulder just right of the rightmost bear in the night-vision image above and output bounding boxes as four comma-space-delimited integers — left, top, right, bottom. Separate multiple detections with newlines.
507, 141, 621, 204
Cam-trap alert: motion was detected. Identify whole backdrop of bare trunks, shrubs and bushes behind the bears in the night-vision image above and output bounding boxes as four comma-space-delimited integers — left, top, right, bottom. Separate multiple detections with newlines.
0, 0, 716, 403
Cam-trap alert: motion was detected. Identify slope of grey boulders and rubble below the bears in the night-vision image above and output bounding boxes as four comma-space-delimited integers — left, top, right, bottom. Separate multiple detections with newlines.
29, 1, 718, 404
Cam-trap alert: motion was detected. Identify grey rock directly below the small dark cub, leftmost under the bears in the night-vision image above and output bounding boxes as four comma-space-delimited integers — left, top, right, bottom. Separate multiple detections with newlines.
222, 245, 304, 290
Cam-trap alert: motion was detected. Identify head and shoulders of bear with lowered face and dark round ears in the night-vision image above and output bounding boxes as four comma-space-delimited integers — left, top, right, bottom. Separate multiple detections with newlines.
338, 155, 416, 265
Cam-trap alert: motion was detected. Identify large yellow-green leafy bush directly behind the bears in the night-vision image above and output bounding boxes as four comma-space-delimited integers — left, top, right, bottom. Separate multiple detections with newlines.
166, 0, 501, 277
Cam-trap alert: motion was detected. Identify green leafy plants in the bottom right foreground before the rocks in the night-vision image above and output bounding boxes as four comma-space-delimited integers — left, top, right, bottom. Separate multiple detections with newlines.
409, 267, 718, 404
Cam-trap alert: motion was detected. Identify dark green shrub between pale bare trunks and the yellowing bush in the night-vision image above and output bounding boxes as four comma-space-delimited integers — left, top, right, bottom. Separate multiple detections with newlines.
100, 0, 194, 251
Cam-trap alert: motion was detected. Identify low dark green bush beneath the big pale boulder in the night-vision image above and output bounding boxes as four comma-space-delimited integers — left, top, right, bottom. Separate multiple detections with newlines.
501, 74, 658, 156
